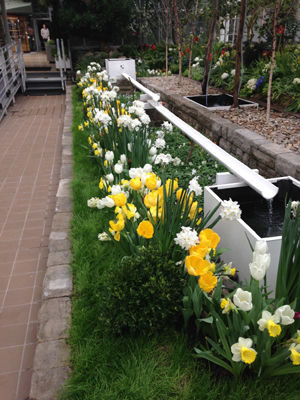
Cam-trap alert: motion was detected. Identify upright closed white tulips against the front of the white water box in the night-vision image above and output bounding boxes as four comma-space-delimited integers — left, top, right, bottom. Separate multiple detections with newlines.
249, 240, 271, 281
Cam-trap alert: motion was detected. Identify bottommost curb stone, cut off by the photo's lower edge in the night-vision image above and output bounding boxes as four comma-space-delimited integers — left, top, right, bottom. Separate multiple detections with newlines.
30, 367, 70, 400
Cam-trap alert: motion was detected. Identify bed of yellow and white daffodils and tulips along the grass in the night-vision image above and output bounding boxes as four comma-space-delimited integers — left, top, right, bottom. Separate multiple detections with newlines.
74, 64, 300, 377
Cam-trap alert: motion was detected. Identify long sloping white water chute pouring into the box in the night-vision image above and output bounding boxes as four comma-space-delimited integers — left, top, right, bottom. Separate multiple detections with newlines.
122, 73, 278, 199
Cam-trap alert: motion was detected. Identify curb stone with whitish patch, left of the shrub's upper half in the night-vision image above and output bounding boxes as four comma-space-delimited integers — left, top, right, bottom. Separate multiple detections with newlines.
43, 265, 72, 299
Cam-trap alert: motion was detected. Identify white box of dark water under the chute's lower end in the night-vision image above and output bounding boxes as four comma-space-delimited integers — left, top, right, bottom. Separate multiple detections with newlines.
204, 173, 300, 290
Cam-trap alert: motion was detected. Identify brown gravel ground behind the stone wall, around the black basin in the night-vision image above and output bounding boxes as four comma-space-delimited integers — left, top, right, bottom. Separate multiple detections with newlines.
148, 75, 300, 154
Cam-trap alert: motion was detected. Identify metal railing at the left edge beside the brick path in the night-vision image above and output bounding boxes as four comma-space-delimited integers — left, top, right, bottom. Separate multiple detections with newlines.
0, 39, 26, 121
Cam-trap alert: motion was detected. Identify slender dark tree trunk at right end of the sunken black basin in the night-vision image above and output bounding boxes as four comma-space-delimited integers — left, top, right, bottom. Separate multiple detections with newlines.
230, 0, 246, 108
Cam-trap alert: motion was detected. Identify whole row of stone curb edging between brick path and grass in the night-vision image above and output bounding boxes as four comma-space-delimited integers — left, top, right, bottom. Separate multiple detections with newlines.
29, 86, 73, 400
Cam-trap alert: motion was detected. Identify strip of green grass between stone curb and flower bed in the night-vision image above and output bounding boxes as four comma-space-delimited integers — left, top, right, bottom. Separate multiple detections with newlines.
60, 90, 300, 400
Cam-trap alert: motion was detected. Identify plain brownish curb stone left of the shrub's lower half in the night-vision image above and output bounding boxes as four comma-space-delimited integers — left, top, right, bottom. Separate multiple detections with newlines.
37, 297, 72, 342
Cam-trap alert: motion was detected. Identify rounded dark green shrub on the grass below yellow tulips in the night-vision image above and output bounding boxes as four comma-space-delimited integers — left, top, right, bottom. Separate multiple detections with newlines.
99, 247, 184, 335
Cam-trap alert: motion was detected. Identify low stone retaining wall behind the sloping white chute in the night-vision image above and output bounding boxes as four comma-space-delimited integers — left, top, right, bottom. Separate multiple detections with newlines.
139, 78, 300, 180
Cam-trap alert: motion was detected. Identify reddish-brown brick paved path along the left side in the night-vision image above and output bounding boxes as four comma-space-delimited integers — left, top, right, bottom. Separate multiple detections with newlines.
0, 95, 65, 400
